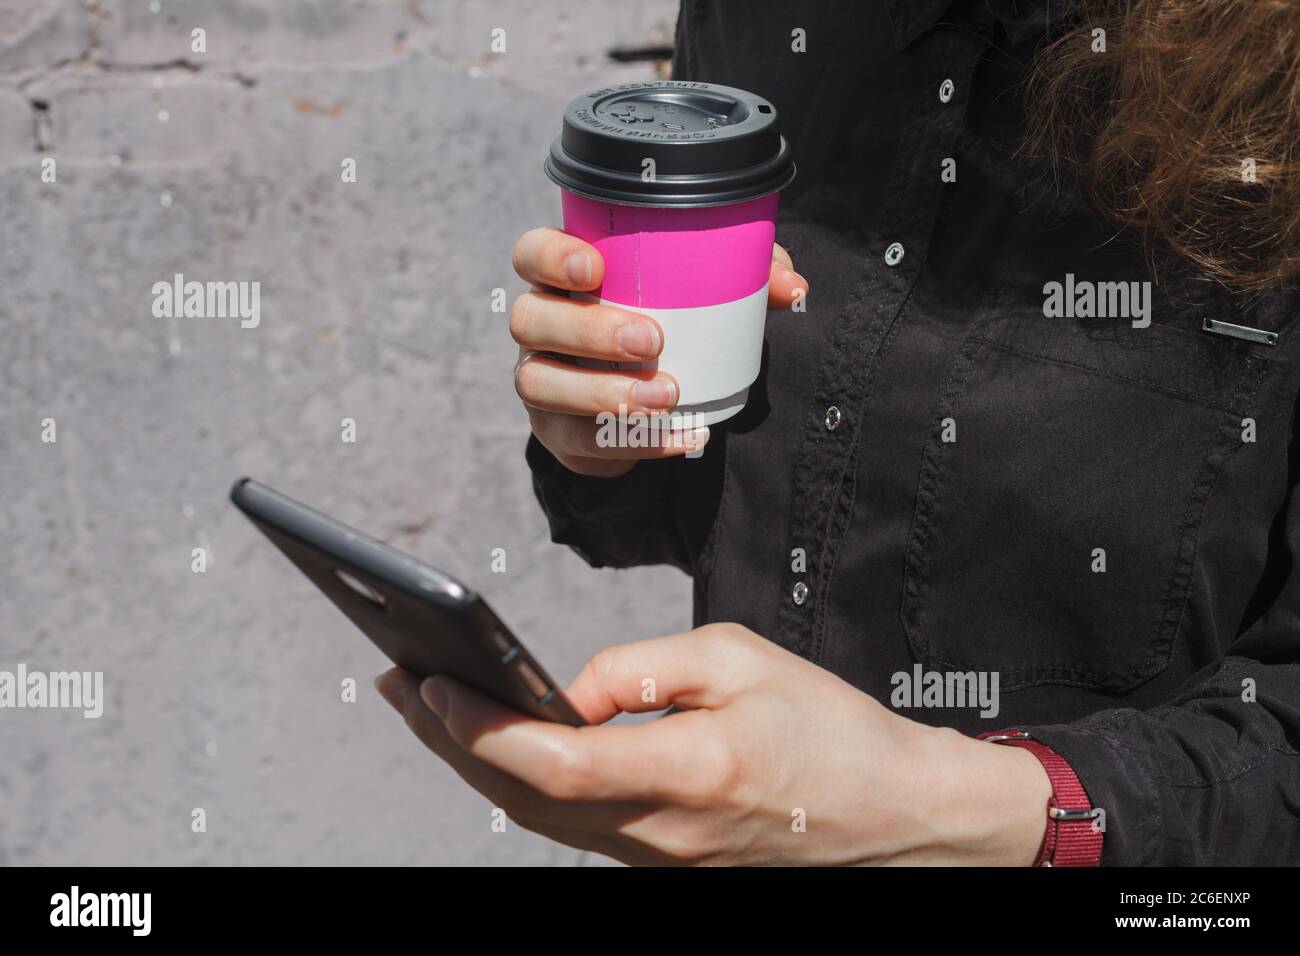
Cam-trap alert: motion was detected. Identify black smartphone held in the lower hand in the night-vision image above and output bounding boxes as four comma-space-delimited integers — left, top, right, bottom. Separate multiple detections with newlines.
230, 477, 586, 727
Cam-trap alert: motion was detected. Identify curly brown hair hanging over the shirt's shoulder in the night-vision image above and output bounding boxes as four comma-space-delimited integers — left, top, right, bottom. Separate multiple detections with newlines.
1027, 0, 1300, 291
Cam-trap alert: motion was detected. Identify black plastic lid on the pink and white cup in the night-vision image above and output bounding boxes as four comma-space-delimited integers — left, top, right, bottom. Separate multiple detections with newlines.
545, 79, 794, 207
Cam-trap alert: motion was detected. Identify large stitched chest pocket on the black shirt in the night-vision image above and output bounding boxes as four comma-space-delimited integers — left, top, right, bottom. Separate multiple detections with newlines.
901, 315, 1268, 691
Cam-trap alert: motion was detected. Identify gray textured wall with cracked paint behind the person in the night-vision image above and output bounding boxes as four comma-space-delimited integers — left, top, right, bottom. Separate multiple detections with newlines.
0, 0, 690, 864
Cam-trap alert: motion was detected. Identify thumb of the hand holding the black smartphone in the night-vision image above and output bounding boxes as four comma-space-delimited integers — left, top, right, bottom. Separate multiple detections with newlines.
566, 626, 748, 723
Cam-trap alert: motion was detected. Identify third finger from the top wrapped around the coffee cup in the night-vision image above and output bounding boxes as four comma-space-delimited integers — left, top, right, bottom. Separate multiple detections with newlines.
515, 352, 677, 415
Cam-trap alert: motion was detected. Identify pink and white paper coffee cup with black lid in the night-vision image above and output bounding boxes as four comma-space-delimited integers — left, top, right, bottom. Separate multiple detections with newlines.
545, 81, 794, 428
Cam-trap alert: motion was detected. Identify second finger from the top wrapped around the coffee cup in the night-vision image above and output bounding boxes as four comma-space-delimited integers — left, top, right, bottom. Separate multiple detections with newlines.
510, 291, 663, 362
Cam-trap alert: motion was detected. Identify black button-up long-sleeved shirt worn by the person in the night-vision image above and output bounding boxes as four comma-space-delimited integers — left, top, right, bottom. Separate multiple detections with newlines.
528, 0, 1300, 864
